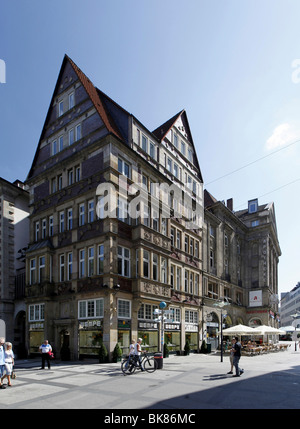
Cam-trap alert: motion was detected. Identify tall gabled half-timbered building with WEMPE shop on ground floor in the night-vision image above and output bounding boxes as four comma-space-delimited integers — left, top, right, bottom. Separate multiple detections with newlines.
26, 55, 203, 358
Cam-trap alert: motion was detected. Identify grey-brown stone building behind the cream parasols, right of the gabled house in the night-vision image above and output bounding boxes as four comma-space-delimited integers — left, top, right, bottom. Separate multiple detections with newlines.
203, 190, 281, 344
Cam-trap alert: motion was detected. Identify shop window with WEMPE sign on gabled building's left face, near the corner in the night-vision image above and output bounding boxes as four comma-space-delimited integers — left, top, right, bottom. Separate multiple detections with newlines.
78, 319, 103, 359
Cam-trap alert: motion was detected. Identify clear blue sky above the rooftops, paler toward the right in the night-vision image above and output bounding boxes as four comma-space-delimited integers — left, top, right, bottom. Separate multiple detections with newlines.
0, 0, 300, 292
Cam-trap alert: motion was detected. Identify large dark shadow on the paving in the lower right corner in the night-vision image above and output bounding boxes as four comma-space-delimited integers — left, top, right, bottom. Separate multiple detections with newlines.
147, 365, 300, 409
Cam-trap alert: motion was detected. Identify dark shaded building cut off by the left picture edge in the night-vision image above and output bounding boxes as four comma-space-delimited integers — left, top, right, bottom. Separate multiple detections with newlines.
0, 178, 29, 356
